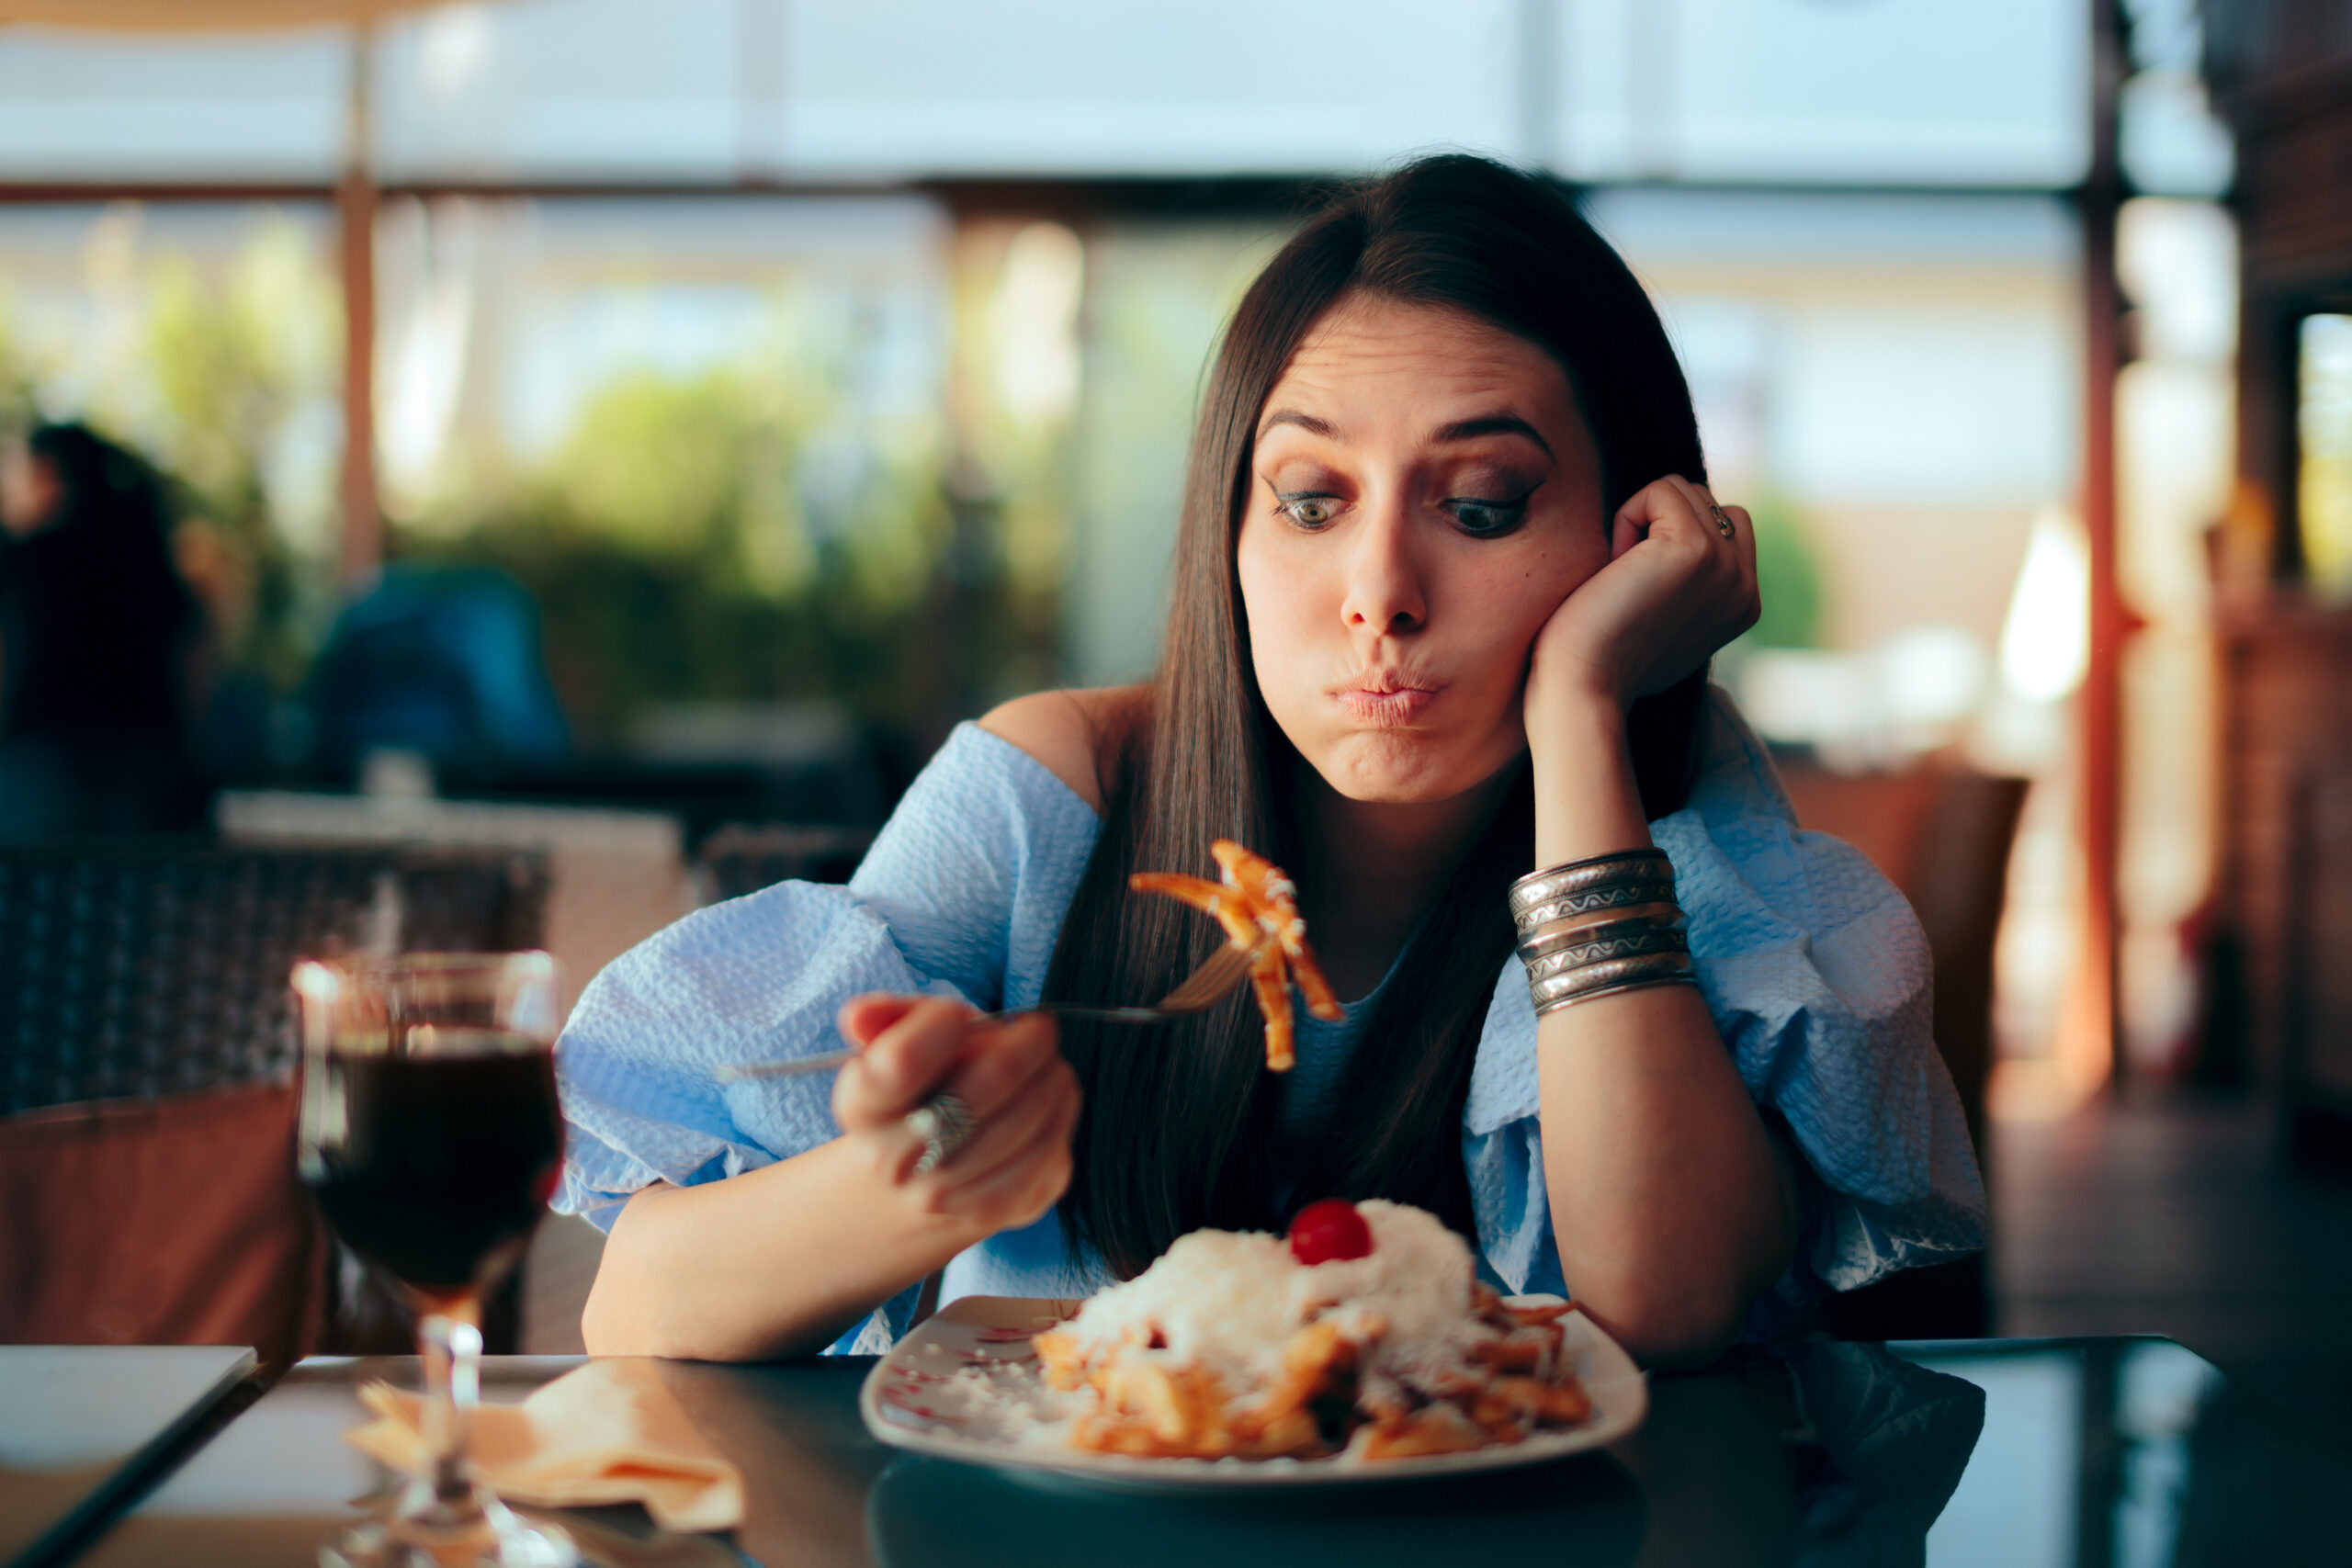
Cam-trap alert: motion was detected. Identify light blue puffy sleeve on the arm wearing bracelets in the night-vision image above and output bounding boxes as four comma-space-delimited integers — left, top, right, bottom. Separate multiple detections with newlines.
1463, 691, 1985, 1331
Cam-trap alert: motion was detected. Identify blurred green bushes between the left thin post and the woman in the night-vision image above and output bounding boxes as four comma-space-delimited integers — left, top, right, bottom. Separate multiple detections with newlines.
393, 367, 1051, 750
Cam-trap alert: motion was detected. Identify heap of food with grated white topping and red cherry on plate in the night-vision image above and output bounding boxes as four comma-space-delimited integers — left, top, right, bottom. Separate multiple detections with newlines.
1035, 1199, 1592, 1460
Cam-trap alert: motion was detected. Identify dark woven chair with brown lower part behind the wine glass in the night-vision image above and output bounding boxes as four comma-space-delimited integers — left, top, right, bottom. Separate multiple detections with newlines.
0, 840, 546, 1361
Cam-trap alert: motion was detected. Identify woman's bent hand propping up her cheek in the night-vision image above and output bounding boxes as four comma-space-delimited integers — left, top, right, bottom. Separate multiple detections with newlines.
1526, 475, 1759, 731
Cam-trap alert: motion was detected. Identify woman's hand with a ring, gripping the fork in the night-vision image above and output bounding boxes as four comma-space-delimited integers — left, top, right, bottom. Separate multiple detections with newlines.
832, 995, 1080, 1236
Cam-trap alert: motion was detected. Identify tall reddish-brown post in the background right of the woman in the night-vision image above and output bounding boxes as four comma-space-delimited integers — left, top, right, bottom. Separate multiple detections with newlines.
2076, 0, 2129, 1089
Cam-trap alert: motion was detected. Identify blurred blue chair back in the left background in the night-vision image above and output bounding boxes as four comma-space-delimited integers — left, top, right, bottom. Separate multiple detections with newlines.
303, 567, 570, 773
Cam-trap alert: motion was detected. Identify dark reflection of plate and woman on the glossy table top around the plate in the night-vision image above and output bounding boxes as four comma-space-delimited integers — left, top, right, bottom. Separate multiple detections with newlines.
842, 1345, 1985, 1568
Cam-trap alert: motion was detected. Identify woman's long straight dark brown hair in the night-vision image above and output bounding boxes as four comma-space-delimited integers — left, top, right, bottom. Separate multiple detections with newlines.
1045, 155, 1705, 1277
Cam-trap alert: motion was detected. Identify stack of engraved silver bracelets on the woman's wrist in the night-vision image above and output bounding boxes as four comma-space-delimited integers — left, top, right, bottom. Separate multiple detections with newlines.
1510, 849, 1696, 1016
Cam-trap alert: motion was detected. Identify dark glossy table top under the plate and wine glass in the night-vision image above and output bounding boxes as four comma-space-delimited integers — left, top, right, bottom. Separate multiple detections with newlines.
32, 1340, 2352, 1568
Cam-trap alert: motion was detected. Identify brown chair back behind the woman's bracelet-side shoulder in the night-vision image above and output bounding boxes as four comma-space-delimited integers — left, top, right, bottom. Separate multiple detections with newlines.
1781, 760, 2028, 1340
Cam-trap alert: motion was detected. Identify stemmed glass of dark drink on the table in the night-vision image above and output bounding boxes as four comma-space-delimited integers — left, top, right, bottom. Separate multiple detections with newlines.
294, 952, 579, 1568
